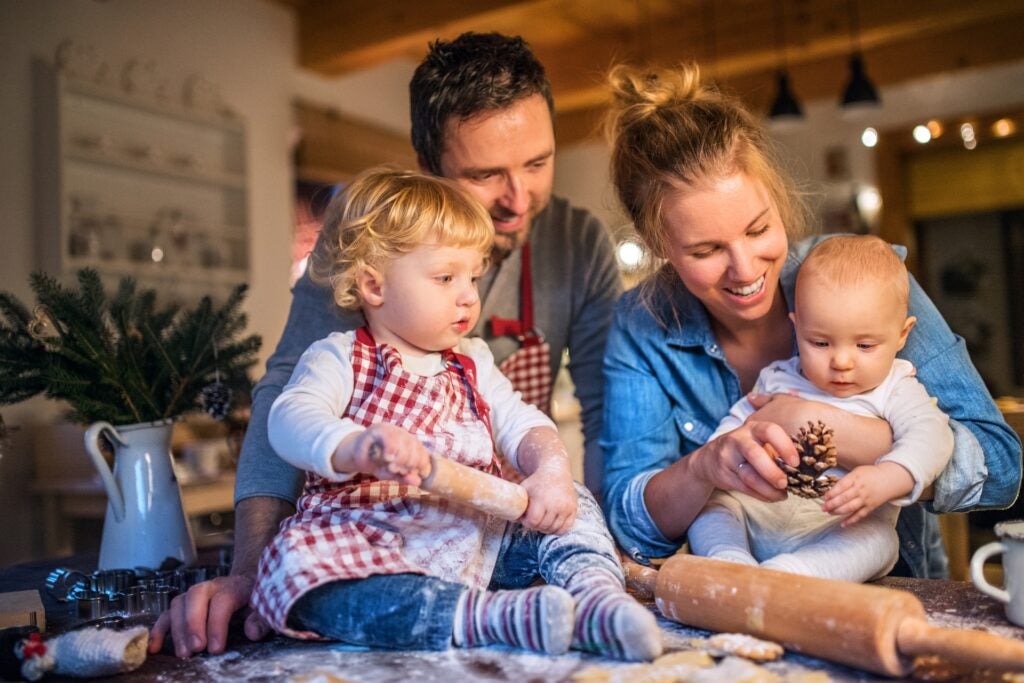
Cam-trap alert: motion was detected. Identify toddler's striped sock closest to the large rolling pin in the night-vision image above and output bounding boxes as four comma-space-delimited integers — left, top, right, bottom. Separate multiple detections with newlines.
565, 568, 662, 661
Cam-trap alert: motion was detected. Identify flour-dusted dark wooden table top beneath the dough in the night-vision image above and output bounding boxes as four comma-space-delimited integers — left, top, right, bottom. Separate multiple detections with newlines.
0, 556, 1024, 683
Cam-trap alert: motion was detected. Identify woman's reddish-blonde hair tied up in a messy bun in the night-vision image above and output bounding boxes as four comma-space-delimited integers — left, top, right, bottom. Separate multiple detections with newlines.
605, 63, 807, 258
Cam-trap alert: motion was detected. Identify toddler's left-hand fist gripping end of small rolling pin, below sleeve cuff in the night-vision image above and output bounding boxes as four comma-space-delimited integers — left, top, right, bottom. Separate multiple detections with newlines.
335, 424, 430, 486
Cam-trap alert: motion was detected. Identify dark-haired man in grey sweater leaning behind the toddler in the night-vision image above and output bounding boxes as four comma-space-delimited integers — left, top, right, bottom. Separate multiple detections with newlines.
150, 33, 622, 656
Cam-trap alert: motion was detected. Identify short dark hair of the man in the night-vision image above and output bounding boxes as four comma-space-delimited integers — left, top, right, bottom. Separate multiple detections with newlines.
409, 32, 555, 175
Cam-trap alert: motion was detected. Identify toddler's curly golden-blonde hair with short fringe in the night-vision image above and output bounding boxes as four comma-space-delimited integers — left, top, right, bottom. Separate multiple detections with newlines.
309, 167, 494, 309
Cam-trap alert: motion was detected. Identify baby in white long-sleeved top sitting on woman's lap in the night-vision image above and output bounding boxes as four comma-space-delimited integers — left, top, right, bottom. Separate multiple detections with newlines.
687, 236, 953, 582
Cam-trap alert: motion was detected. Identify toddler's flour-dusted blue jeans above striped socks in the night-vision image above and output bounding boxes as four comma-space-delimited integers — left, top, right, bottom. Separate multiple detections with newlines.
288, 484, 623, 650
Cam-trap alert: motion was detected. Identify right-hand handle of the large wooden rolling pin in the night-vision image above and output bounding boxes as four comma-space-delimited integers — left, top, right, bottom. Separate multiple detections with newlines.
896, 618, 1024, 671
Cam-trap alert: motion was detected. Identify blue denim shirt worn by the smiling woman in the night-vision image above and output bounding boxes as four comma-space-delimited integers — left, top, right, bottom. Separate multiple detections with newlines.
601, 237, 1021, 577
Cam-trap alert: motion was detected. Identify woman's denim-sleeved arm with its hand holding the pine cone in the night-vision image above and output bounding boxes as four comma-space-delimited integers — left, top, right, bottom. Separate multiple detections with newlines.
601, 296, 796, 562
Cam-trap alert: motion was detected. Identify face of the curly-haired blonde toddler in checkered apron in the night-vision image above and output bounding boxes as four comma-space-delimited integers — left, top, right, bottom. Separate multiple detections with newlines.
367, 245, 484, 354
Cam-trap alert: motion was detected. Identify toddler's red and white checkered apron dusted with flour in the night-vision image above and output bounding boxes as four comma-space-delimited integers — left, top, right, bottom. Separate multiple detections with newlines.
252, 329, 505, 639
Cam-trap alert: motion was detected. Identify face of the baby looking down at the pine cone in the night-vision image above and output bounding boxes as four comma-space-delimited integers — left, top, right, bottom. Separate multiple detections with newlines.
792, 279, 914, 398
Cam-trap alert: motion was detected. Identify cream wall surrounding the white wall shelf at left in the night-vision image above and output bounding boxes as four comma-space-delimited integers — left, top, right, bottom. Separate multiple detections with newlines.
0, 0, 296, 566
